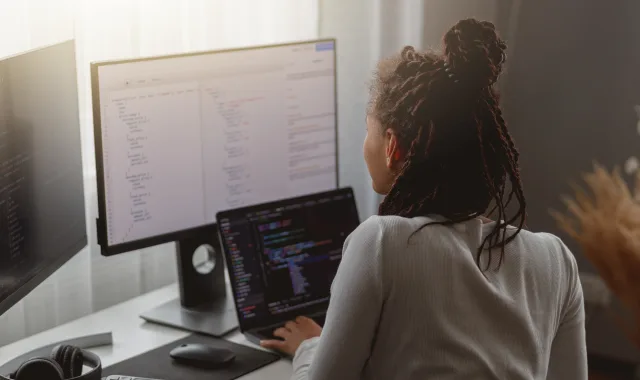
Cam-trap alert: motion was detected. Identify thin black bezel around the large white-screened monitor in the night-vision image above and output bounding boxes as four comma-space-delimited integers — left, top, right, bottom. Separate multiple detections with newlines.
90, 38, 340, 256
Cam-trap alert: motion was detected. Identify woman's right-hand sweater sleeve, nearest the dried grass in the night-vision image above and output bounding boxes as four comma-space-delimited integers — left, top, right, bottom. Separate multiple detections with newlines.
547, 242, 588, 380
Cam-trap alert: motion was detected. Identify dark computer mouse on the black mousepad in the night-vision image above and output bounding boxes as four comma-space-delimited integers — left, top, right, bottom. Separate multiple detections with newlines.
169, 343, 236, 368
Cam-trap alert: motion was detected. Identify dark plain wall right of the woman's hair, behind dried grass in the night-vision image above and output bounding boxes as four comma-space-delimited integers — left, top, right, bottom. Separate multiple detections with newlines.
496, 0, 640, 362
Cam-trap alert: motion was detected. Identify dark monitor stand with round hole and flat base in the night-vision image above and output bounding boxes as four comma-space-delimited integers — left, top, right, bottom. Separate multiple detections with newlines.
140, 225, 238, 337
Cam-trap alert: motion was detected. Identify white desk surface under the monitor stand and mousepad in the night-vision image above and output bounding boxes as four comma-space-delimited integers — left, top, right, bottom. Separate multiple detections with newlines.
0, 285, 292, 380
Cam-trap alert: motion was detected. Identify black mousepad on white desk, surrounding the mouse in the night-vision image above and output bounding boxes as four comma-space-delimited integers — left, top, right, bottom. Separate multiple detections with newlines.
102, 334, 280, 380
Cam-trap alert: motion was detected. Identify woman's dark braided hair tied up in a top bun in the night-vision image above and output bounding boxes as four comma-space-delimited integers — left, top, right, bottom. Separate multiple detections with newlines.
369, 19, 526, 269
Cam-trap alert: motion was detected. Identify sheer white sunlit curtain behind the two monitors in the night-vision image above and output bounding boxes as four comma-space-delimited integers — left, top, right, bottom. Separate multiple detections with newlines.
0, 0, 318, 345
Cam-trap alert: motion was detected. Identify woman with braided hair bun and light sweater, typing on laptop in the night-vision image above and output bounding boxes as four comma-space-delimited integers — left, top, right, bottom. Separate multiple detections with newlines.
263, 19, 587, 380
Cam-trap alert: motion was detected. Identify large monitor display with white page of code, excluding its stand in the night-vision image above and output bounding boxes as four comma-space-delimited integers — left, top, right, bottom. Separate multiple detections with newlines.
92, 40, 338, 254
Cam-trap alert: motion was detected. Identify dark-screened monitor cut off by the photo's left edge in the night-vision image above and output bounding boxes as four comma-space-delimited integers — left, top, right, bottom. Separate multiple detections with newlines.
0, 41, 87, 314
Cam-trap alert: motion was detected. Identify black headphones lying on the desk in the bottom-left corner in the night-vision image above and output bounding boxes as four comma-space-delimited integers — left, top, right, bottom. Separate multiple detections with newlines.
0, 344, 102, 380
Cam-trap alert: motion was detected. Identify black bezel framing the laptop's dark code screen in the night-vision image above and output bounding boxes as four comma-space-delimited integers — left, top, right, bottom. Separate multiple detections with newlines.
216, 187, 360, 333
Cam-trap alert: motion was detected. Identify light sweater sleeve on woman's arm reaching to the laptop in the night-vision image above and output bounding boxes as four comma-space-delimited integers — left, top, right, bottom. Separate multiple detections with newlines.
293, 217, 383, 380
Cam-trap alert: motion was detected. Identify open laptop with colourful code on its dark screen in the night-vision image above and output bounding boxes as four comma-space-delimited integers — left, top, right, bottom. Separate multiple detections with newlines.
216, 188, 360, 344
